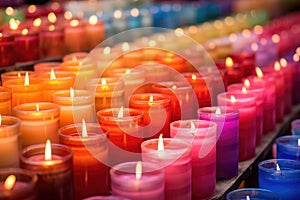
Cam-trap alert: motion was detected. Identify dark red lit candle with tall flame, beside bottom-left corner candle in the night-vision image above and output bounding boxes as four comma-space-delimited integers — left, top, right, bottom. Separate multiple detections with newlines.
20, 140, 73, 200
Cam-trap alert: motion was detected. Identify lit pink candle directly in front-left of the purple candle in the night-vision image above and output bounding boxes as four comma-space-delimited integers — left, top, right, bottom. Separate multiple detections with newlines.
170, 120, 217, 199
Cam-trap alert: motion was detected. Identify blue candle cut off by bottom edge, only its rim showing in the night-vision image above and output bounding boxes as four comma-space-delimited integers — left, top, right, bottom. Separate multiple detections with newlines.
226, 188, 280, 200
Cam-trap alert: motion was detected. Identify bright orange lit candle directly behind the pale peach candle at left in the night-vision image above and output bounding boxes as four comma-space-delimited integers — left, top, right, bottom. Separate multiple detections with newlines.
3, 73, 43, 108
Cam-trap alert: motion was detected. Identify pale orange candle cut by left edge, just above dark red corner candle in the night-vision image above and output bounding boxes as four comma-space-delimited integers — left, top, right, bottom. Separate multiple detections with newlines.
0, 115, 21, 168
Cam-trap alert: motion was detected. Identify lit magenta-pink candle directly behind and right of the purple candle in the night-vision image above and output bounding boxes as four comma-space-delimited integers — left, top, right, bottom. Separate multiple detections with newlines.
218, 91, 257, 161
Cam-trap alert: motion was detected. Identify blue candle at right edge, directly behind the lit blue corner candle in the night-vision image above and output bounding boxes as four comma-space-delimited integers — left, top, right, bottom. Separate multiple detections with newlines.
276, 135, 300, 161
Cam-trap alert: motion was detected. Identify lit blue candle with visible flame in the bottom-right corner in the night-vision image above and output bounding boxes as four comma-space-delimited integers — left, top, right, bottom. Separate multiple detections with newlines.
258, 159, 300, 200
